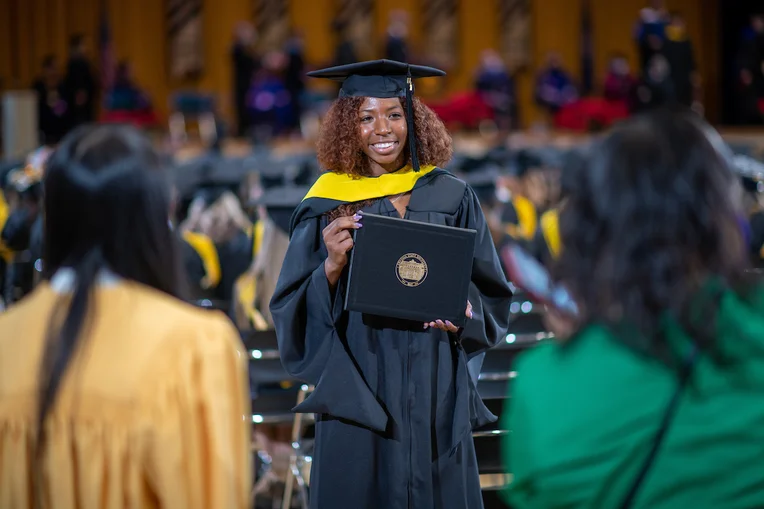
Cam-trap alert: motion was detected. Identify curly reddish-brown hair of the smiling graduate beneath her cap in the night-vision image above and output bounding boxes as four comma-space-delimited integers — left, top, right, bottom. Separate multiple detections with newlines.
318, 97, 454, 176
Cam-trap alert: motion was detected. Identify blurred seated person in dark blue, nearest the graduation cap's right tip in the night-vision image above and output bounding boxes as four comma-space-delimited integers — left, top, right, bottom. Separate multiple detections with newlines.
475, 50, 517, 131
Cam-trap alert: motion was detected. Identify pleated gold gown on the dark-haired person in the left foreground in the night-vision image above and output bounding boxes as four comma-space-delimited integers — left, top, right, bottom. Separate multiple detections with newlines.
0, 277, 252, 509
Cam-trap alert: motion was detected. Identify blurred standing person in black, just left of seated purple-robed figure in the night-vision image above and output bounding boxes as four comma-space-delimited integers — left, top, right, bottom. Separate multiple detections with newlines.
231, 21, 258, 136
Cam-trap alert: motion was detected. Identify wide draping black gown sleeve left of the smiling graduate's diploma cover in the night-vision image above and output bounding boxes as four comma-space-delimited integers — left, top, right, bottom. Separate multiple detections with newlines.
270, 213, 388, 431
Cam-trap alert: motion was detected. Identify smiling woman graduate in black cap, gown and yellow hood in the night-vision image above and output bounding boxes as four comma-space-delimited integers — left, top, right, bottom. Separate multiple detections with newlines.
271, 60, 512, 509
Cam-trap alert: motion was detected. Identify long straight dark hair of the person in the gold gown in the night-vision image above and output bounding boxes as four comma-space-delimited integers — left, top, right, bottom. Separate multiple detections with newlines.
35, 125, 186, 496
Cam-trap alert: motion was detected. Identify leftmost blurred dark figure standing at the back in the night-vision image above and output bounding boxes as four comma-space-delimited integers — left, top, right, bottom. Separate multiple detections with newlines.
32, 55, 69, 145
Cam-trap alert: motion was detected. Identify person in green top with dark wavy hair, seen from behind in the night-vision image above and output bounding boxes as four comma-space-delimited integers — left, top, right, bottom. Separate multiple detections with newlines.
503, 110, 764, 509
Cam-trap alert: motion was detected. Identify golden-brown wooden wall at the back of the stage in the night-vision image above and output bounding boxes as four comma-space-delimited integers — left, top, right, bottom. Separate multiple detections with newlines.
0, 0, 719, 126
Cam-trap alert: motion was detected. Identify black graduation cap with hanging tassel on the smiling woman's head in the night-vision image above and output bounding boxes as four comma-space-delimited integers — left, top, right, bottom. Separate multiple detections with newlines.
308, 60, 446, 171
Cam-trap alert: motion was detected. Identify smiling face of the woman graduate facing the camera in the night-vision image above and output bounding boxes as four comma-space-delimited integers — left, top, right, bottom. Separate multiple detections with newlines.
358, 97, 408, 176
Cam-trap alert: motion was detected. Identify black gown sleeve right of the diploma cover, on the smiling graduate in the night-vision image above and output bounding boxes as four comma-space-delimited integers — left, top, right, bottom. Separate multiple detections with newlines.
459, 187, 512, 358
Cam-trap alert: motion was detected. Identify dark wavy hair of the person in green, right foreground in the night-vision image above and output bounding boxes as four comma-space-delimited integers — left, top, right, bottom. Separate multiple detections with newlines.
555, 109, 748, 361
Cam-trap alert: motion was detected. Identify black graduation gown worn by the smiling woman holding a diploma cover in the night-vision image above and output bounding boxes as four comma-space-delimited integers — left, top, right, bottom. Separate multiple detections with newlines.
271, 169, 512, 509
